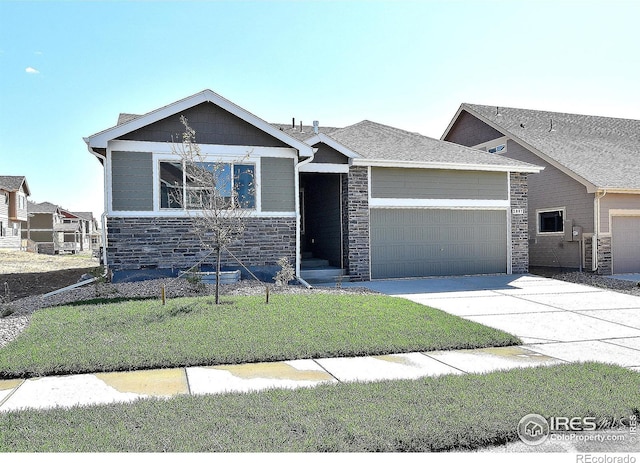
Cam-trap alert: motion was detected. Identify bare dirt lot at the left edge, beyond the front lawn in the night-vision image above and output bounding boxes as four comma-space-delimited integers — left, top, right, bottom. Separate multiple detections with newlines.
0, 250, 98, 301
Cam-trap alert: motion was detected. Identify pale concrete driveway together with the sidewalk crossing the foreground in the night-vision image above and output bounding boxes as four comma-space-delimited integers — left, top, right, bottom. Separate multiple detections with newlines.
0, 275, 640, 412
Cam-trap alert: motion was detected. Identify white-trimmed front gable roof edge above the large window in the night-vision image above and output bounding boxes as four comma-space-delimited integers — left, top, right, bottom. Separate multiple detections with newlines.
84, 90, 313, 156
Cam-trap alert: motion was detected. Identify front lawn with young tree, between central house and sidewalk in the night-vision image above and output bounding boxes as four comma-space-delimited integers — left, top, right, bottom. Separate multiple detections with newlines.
0, 294, 520, 378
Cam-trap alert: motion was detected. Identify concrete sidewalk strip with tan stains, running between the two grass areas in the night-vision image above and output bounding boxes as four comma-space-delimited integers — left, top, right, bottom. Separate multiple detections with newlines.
0, 346, 562, 412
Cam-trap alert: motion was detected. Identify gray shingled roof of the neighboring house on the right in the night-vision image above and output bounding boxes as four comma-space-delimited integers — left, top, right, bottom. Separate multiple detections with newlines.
452, 103, 640, 191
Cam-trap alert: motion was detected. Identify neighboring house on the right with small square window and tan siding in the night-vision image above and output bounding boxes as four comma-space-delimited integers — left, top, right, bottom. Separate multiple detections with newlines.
442, 103, 640, 274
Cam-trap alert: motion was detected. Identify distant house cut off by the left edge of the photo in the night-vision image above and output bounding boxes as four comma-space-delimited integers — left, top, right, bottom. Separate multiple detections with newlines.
0, 175, 31, 249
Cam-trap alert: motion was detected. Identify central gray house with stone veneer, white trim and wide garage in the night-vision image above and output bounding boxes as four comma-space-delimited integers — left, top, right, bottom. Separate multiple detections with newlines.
85, 90, 540, 281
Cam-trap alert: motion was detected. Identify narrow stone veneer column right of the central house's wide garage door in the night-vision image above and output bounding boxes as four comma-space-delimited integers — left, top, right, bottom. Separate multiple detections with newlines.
509, 172, 529, 273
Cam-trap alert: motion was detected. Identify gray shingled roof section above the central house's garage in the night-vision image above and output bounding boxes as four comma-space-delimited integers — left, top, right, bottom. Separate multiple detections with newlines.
330, 120, 542, 172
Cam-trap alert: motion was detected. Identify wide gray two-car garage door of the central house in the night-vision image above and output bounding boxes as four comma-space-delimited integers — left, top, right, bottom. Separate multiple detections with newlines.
371, 209, 507, 278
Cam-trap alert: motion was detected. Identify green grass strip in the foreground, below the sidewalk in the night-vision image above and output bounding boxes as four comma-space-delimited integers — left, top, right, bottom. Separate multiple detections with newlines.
0, 363, 640, 452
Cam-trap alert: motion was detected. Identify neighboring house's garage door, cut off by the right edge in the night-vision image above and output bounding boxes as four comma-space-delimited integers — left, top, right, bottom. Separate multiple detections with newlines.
611, 217, 640, 273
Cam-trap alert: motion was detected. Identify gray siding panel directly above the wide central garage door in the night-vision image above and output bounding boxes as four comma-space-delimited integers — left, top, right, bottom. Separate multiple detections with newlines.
371, 167, 508, 200
